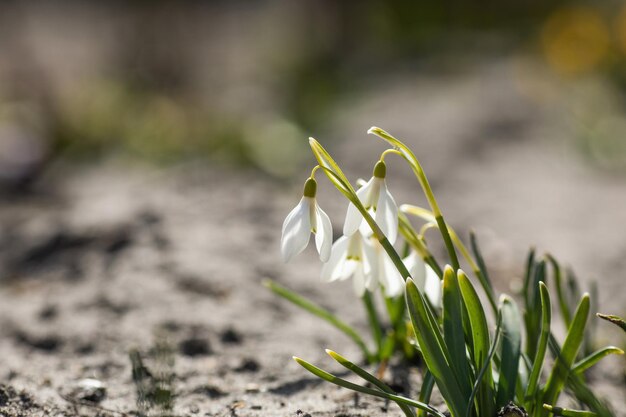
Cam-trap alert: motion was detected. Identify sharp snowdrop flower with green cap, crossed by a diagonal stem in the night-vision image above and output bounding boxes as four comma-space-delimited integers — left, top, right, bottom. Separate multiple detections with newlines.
343, 161, 398, 244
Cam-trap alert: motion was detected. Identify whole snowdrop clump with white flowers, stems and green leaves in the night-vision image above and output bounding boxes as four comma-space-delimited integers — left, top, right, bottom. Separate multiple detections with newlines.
264, 127, 624, 417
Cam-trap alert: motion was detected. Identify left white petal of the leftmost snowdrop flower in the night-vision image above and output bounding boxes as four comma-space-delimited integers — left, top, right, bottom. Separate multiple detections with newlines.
280, 197, 311, 262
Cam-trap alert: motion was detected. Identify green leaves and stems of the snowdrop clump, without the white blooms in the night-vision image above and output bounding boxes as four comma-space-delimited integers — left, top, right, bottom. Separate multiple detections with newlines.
267, 128, 623, 417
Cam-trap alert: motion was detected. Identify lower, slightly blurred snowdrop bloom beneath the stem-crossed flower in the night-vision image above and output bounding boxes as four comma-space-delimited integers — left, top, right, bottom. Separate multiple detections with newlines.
322, 233, 376, 297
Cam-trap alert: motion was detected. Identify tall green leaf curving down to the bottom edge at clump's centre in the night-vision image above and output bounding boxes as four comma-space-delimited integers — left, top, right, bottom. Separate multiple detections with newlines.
458, 271, 500, 416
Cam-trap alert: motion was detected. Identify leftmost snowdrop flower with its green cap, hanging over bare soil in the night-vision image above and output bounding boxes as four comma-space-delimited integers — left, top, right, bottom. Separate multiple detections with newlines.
280, 178, 333, 262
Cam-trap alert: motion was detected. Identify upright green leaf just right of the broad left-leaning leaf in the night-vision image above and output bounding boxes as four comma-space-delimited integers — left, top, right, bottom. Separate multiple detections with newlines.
443, 265, 472, 396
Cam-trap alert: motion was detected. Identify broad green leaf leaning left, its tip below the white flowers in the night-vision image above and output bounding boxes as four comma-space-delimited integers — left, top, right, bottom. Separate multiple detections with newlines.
406, 279, 467, 416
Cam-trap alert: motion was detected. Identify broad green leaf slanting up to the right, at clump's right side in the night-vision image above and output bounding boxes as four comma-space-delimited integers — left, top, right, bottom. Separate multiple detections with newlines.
543, 294, 590, 415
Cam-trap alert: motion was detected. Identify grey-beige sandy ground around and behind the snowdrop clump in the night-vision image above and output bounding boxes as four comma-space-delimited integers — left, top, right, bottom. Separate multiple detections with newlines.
0, 69, 626, 417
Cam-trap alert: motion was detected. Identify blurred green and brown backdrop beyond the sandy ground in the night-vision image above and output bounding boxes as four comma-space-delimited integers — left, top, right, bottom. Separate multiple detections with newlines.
0, 0, 626, 186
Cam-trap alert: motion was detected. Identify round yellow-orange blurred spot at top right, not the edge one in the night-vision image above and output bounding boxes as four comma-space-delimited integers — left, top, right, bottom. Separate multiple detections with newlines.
541, 7, 610, 75
